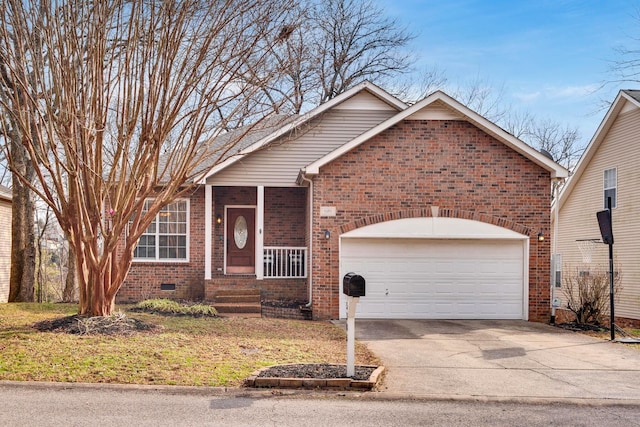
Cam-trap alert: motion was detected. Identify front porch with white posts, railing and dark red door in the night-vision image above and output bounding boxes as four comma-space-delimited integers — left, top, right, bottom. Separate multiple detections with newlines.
204, 186, 310, 312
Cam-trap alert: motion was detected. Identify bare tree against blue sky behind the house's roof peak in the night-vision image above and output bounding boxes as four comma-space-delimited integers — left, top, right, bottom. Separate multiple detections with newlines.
255, 0, 413, 114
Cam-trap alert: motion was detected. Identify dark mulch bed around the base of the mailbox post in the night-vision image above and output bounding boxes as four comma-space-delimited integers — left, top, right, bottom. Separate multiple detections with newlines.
258, 363, 376, 381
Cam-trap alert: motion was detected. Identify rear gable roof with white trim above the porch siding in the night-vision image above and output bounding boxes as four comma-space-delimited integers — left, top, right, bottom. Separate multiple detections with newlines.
198, 81, 407, 183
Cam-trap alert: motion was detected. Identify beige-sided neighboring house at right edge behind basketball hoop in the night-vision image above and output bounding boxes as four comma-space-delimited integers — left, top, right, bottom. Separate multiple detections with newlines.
552, 90, 640, 319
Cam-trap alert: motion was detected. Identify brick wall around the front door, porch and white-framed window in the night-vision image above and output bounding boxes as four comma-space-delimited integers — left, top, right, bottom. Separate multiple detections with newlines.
117, 187, 308, 302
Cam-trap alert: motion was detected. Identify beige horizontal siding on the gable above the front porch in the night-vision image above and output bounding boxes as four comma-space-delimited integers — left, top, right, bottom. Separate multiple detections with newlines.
207, 108, 396, 187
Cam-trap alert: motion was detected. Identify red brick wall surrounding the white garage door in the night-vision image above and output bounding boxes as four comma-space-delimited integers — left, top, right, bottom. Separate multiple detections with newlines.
312, 120, 550, 321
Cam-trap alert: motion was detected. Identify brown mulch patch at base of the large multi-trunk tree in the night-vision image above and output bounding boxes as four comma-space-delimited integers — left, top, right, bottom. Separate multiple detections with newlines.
33, 313, 159, 336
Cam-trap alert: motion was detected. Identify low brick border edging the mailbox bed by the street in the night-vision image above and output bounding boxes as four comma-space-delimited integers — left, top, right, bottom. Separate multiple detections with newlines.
244, 366, 385, 390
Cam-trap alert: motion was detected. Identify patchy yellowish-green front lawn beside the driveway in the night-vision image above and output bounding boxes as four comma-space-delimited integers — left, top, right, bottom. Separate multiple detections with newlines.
0, 303, 379, 387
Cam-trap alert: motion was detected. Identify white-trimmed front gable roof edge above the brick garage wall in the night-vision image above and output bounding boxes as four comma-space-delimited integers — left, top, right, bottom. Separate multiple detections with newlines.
301, 91, 568, 178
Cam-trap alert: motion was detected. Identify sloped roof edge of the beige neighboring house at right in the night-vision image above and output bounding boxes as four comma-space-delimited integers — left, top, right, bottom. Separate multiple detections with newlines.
552, 89, 640, 209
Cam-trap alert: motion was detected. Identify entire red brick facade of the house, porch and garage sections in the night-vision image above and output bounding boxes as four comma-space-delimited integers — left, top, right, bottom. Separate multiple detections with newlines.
118, 120, 550, 321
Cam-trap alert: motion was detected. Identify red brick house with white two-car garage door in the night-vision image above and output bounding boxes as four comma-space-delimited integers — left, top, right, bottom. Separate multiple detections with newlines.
118, 83, 567, 321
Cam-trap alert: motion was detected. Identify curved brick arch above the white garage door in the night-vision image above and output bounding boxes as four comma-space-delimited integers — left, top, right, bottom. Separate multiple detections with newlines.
340, 207, 531, 236
